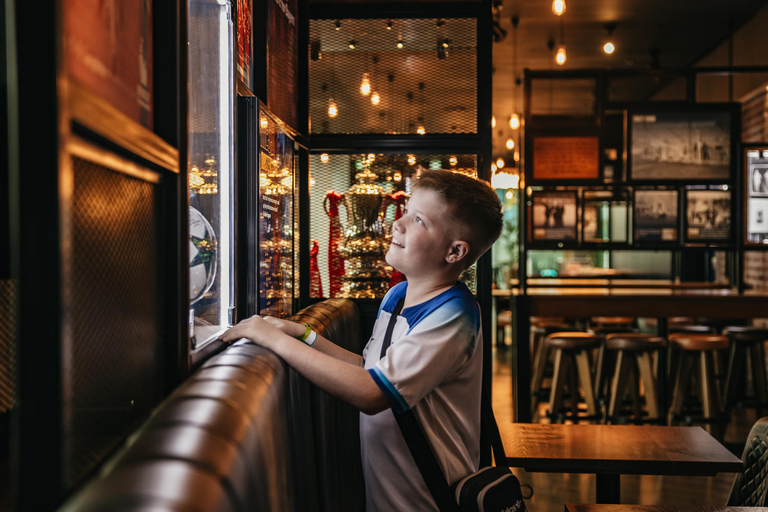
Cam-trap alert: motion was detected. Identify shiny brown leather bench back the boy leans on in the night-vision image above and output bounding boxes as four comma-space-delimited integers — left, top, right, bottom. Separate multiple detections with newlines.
58, 300, 365, 512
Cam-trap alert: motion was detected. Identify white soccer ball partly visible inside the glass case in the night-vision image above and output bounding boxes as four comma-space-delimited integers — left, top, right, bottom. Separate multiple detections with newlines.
189, 206, 218, 306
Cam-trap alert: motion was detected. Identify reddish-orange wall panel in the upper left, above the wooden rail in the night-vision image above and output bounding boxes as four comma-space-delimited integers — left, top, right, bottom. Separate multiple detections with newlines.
62, 0, 153, 129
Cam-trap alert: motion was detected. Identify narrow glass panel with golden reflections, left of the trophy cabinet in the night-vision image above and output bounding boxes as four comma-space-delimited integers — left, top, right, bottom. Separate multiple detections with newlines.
258, 110, 296, 318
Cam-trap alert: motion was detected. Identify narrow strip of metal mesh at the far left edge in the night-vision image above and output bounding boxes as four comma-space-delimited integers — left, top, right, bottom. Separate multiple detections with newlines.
0, 279, 18, 413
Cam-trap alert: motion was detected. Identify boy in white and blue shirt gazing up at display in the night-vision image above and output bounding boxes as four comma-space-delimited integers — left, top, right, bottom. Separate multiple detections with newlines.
222, 171, 502, 512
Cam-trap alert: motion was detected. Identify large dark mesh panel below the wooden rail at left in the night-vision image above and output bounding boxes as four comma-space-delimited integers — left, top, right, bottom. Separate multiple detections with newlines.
64, 158, 165, 484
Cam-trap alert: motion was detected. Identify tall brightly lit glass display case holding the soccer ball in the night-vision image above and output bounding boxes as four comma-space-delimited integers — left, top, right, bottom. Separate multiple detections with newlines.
187, 0, 234, 350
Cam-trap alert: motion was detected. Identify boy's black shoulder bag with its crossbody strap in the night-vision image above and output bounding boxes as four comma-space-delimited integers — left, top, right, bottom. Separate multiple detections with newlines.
381, 299, 533, 512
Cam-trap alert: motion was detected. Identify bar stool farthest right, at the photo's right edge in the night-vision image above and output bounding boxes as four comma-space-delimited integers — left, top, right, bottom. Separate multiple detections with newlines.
723, 326, 768, 417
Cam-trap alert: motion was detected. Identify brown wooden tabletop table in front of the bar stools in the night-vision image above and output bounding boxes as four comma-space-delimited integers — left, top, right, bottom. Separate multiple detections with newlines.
499, 423, 742, 503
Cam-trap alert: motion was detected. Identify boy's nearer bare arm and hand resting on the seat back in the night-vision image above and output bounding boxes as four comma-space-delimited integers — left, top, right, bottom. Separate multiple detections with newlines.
221, 316, 390, 414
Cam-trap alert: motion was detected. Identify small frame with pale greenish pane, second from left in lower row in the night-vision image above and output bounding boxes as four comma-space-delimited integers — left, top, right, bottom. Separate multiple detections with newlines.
581, 190, 629, 243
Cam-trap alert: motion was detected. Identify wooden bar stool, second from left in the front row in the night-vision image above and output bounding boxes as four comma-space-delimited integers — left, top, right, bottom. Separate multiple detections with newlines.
605, 333, 667, 423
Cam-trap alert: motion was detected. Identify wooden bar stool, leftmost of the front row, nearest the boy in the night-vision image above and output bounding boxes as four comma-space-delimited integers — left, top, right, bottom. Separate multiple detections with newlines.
545, 332, 600, 421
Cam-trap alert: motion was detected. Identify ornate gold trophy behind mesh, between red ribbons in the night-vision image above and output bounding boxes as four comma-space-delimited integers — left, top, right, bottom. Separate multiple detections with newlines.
339, 168, 389, 299
